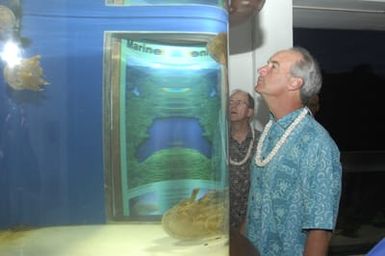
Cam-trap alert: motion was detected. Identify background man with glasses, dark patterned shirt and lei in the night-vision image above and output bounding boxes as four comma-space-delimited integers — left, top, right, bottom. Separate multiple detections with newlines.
229, 90, 260, 231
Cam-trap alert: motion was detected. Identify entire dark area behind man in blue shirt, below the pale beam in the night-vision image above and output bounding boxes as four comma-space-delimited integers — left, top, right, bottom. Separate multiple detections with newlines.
294, 29, 385, 255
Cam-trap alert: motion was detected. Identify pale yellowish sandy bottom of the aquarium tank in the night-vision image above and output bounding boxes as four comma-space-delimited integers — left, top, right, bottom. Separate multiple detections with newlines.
0, 224, 229, 256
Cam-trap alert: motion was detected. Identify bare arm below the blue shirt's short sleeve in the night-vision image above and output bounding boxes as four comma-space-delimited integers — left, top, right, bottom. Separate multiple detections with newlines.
303, 229, 332, 256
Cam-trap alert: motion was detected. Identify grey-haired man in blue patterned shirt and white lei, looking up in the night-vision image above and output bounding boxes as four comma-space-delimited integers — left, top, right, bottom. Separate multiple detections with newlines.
246, 48, 341, 256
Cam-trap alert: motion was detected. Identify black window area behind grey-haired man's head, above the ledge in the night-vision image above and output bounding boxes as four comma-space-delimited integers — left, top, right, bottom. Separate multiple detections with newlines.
294, 28, 385, 151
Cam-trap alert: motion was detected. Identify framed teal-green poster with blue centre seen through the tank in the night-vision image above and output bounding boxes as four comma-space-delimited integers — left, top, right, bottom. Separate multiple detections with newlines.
105, 32, 227, 220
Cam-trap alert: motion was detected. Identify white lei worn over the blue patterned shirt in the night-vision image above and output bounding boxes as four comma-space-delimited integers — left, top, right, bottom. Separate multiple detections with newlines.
255, 108, 308, 167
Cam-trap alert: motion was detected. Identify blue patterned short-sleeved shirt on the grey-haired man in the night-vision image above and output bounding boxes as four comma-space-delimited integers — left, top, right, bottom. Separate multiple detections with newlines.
247, 109, 342, 256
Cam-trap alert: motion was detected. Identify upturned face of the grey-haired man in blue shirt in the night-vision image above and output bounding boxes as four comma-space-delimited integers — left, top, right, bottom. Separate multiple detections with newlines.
255, 51, 300, 96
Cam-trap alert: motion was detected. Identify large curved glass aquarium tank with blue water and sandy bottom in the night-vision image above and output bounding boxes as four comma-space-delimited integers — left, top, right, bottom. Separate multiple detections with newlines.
0, 0, 228, 256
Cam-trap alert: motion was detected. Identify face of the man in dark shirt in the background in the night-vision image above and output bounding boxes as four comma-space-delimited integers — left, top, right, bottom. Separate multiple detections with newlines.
229, 92, 253, 122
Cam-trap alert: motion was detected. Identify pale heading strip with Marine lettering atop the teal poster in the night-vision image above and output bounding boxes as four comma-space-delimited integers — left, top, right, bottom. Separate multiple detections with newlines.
127, 40, 209, 58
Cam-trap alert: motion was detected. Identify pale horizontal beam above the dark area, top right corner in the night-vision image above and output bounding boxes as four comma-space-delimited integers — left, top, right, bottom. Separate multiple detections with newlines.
292, 0, 385, 31
